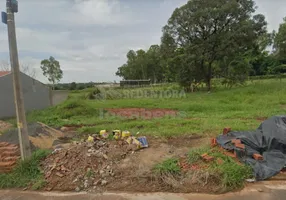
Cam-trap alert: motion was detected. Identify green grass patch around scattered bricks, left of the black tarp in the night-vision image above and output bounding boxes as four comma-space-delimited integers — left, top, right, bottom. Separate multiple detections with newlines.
188, 147, 253, 191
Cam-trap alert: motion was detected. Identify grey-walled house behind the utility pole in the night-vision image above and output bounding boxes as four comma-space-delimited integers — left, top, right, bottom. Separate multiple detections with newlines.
0, 71, 52, 119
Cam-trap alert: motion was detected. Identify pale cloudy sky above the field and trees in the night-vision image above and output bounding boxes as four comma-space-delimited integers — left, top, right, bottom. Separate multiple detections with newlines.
0, 0, 286, 83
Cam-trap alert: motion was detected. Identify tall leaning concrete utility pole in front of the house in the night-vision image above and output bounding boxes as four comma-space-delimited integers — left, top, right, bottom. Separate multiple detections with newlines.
6, 0, 31, 160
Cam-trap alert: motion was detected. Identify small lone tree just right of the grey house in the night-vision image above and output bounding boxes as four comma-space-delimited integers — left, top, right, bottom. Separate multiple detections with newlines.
41, 56, 63, 89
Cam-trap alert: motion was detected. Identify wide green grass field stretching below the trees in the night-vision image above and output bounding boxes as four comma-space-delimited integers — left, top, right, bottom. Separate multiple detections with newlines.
25, 79, 286, 136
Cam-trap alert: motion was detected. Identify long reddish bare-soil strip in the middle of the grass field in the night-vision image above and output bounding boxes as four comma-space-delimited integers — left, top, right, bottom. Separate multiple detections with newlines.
106, 108, 178, 119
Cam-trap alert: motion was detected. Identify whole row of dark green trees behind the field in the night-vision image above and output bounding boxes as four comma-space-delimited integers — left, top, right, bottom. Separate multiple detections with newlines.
116, 0, 286, 90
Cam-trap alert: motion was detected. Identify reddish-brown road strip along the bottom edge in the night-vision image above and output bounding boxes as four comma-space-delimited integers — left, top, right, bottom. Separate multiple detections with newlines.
0, 183, 286, 200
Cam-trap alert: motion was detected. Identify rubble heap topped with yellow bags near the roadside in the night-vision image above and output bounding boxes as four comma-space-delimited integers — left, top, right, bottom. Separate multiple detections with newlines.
42, 130, 148, 191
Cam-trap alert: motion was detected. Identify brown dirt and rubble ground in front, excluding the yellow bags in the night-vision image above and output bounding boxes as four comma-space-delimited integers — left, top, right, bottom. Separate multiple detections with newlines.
42, 136, 219, 193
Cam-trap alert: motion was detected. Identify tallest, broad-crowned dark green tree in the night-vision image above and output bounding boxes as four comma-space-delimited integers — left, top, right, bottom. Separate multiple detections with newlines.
162, 0, 267, 90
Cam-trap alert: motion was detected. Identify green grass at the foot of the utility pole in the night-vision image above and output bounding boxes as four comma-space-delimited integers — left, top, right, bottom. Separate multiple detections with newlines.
0, 150, 49, 190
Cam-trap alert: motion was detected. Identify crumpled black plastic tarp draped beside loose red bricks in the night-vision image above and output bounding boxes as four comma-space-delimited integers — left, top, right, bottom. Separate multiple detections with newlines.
217, 116, 286, 180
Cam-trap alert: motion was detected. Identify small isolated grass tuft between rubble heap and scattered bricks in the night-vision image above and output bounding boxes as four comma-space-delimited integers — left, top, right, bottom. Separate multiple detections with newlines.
154, 158, 181, 175
